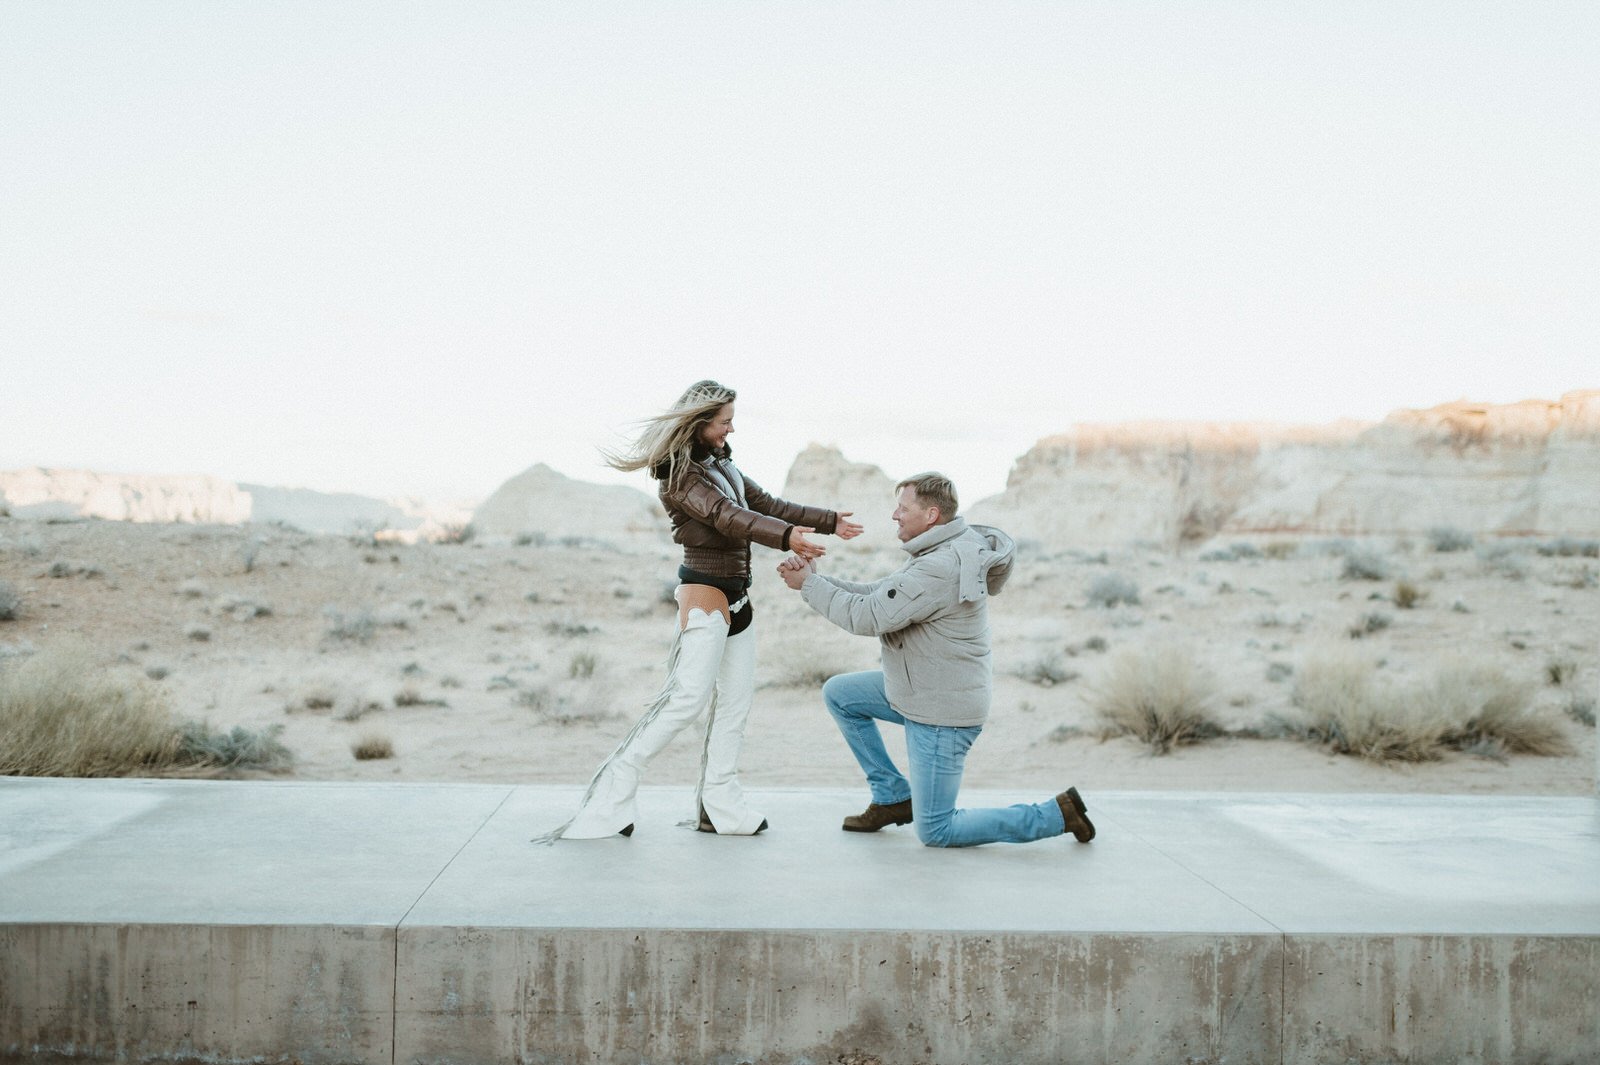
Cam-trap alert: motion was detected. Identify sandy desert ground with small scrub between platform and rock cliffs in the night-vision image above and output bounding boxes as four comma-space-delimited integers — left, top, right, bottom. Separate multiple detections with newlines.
0, 518, 1600, 795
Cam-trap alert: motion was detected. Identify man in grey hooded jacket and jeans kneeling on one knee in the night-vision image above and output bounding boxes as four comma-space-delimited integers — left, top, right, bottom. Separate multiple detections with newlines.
778, 473, 1094, 848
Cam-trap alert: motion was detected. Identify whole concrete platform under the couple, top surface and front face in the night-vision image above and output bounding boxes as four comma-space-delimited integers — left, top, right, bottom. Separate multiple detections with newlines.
0, 779, 1600, 1065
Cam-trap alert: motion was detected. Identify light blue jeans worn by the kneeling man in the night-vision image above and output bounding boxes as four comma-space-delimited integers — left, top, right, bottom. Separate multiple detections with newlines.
822, 670, 1067, 848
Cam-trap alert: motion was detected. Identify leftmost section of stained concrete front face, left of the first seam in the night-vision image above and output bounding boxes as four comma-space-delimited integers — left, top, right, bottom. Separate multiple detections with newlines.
0, 924, 395, 1065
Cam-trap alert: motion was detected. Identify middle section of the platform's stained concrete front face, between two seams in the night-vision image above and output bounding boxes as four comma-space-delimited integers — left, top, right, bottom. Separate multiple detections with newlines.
395, 929, 1282, 1065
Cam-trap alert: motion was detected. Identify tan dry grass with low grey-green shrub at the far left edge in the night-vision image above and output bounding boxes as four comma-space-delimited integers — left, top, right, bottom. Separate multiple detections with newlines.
0, 648, 290, 777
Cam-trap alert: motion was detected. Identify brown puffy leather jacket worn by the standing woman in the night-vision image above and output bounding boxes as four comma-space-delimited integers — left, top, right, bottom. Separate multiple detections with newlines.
656, 445, 838, 579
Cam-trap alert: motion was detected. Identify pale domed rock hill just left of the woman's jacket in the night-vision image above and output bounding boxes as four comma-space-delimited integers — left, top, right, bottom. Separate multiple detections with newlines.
472, 462, 669, 544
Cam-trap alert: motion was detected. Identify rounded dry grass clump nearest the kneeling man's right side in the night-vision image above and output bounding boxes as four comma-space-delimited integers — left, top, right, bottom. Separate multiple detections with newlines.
1090, 644, 1222, 755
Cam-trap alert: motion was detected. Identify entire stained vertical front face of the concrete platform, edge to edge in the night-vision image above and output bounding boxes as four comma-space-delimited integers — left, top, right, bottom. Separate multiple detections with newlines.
0, 924, 1600, 1065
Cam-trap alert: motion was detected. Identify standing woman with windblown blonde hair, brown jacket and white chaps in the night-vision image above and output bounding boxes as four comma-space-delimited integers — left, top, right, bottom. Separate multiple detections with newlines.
534, 381, 861, 843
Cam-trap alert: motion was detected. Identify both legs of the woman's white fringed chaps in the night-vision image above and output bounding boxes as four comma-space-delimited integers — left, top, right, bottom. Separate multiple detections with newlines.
534, 598, 763, 843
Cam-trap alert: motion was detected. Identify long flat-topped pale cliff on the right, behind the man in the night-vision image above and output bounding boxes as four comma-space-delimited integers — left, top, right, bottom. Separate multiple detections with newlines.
973, 390, 1600, 545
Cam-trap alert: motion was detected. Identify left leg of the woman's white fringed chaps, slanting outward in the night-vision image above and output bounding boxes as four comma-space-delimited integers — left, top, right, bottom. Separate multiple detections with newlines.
536, 611, 728, 841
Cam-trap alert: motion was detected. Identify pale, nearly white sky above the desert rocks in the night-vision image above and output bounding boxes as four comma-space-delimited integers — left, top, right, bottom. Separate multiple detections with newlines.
0, 0, 1600, 504
